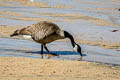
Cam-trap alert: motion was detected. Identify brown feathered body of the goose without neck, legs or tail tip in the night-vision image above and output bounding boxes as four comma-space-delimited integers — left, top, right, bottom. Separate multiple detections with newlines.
20, 21, 64, 44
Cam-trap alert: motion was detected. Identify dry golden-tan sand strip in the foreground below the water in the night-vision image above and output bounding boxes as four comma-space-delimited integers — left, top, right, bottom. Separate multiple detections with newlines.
0, 57, 120, 80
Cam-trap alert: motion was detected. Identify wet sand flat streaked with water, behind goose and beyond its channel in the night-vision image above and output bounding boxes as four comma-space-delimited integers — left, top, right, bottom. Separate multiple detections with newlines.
0, 0, 120, 51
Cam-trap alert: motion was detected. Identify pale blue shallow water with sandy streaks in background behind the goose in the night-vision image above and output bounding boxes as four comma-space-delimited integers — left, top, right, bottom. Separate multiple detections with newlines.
0, 0, 120, 43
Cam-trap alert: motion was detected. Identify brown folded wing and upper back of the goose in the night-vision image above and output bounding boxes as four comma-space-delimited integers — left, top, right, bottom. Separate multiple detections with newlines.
20, 21, 60, 40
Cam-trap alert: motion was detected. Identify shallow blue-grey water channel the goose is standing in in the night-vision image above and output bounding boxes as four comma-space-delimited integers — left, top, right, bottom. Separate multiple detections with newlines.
0, 38, 120, 65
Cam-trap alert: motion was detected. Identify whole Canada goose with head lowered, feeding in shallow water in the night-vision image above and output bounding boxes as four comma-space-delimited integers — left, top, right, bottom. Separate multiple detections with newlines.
10, 21, 82, 57
